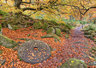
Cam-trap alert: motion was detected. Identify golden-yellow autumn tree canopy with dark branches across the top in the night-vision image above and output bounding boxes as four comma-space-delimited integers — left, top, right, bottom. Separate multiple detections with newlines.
1, 0, 96, 19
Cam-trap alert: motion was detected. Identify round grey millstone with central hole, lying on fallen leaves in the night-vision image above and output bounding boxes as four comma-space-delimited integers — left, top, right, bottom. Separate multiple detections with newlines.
18, 40, 51, 64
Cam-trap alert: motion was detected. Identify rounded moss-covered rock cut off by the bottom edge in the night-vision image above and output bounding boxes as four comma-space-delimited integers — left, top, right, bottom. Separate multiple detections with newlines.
60, 58, 87, 68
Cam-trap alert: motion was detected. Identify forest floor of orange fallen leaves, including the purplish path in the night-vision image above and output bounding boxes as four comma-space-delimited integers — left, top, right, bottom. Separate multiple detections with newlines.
0, 26, 96, 68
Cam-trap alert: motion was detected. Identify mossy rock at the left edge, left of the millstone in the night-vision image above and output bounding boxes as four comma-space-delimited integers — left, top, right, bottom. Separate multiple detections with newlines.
0, 34, 18, 48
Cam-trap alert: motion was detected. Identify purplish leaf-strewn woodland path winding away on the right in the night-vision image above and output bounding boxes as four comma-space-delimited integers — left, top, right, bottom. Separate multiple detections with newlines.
57, 25, 95, 63
